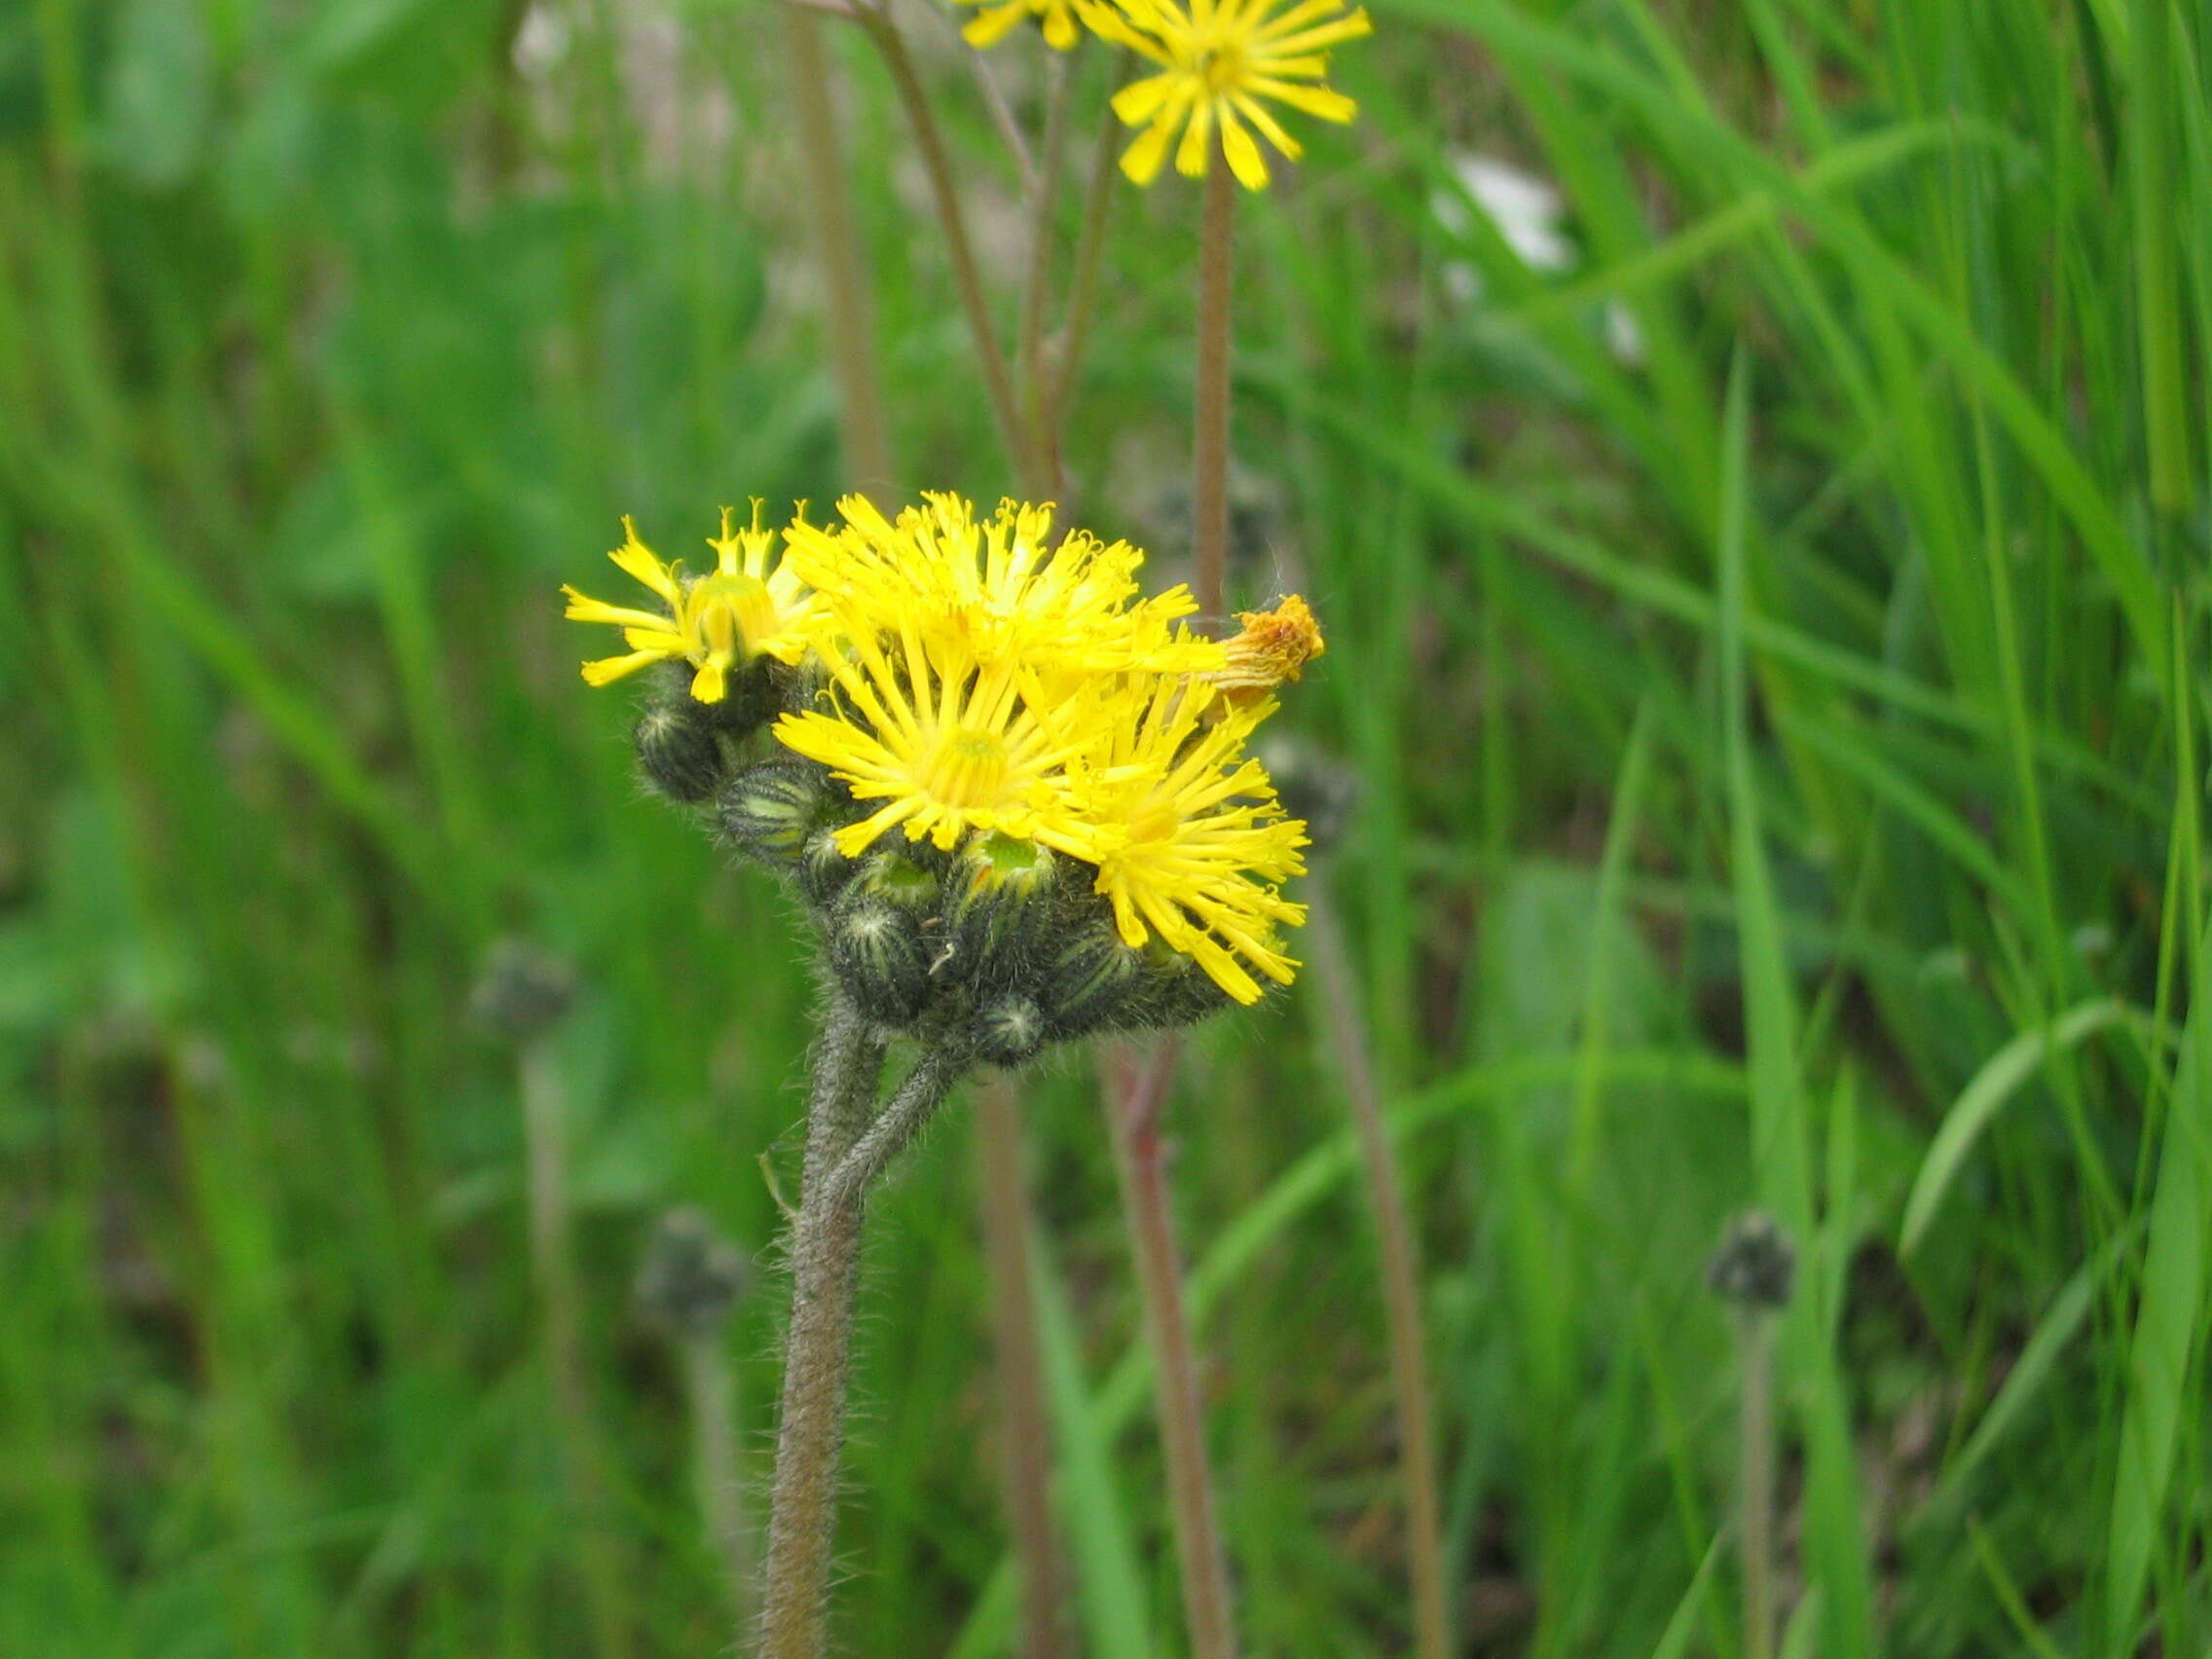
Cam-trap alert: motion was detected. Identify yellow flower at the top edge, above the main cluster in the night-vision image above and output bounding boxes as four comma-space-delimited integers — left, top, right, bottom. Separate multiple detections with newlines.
1077, 0, 1374, 190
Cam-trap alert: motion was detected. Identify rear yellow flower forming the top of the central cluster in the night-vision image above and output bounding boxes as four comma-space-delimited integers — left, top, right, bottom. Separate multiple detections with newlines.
786, 494, 1228, 680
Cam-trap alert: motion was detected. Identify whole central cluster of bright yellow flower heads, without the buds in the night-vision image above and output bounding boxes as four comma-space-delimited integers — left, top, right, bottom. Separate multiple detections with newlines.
564, 496, 1323, 1002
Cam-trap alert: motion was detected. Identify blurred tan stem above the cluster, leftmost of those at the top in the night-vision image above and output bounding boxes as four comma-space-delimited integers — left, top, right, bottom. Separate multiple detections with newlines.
783, 5, 894, 494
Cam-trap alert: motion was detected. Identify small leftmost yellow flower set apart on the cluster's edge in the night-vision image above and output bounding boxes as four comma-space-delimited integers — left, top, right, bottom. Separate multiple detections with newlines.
562, 513, 821, 703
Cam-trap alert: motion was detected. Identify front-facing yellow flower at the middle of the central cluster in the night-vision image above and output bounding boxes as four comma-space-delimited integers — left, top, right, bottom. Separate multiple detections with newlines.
774, 612, 1092, 859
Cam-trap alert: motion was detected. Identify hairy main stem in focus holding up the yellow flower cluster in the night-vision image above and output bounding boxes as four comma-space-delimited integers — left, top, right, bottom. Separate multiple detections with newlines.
761, 991, 883, 1659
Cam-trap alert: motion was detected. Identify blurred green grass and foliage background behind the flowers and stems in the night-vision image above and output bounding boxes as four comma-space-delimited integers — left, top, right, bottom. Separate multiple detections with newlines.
0, 0, 2212, 1659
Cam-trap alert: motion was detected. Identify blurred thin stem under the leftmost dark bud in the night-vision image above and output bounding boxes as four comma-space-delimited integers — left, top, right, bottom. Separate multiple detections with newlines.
520, 1035, 631, 1659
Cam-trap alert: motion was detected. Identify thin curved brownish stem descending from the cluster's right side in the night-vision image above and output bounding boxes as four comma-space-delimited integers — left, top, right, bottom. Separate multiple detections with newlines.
1305, 880, 1451, 1659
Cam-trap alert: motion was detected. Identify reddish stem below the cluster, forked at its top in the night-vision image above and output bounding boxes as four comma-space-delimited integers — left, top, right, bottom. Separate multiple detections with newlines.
1106, 1038, 1236, 1659
